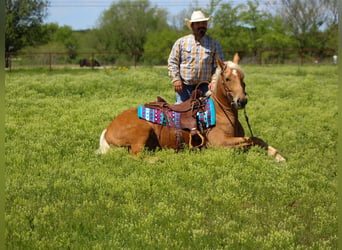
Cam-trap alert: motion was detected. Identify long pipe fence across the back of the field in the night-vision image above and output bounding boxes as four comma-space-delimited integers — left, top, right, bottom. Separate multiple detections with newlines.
6, 49, 337, 70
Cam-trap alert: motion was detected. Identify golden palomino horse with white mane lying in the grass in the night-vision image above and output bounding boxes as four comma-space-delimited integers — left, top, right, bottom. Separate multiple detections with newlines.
97, 54, 285, 161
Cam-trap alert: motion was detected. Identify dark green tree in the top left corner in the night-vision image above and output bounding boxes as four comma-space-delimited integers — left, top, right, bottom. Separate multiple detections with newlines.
5, 0, 48, 52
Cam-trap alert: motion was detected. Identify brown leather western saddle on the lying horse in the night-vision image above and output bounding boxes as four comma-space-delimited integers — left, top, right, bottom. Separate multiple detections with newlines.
144, 90, 208, 149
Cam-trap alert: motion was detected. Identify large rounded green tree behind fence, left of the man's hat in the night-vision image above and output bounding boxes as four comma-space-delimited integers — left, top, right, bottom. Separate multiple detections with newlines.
96, 0, 167, 63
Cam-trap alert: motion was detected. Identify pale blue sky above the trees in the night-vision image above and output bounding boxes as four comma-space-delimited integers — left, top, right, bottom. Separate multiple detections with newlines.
45, 0, 216, 30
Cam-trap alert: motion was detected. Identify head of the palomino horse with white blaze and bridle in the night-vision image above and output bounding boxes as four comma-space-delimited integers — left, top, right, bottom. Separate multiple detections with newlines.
214, 53, 247, 109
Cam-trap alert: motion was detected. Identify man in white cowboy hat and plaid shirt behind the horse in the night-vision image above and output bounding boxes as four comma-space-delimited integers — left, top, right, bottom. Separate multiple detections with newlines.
168, 11, 224, 104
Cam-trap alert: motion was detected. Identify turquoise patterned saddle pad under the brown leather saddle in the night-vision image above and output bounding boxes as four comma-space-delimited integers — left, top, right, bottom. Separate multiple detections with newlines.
138, 98, 216, 128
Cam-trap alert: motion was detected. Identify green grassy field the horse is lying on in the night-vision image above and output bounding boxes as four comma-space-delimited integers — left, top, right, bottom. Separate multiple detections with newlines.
5, 65, 338, 250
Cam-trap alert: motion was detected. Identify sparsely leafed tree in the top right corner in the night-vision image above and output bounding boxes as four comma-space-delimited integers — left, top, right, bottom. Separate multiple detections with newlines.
264, 0, 338, 62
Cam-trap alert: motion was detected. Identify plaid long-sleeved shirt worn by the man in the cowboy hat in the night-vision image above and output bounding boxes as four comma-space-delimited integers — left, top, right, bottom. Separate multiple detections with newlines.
168, 34, 224, 85
